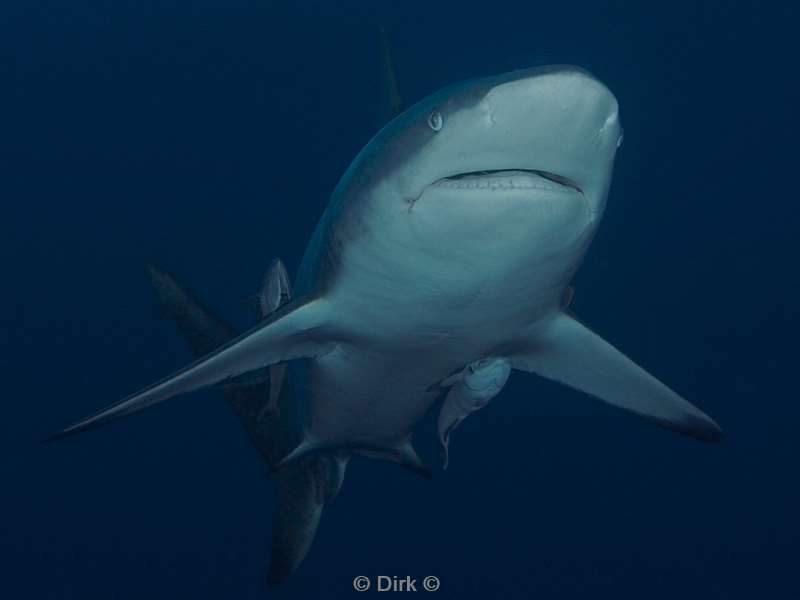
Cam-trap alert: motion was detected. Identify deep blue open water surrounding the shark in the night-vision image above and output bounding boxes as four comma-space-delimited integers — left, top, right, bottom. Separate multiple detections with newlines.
0, 0, 800, 599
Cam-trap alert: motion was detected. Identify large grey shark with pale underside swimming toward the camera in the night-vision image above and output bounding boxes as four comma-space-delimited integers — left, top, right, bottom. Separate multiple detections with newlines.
54, 66, 721, 580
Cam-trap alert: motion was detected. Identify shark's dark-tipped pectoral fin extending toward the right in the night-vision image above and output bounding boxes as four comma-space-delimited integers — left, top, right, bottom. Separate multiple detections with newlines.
511, 314, 722, 442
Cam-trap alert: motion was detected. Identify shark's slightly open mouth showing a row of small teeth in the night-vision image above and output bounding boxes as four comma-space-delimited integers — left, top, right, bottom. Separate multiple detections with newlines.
433, 169, 583, 194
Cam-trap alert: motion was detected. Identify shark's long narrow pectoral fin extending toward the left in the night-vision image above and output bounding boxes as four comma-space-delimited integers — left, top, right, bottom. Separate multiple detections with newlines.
50, 298, 334, 439
